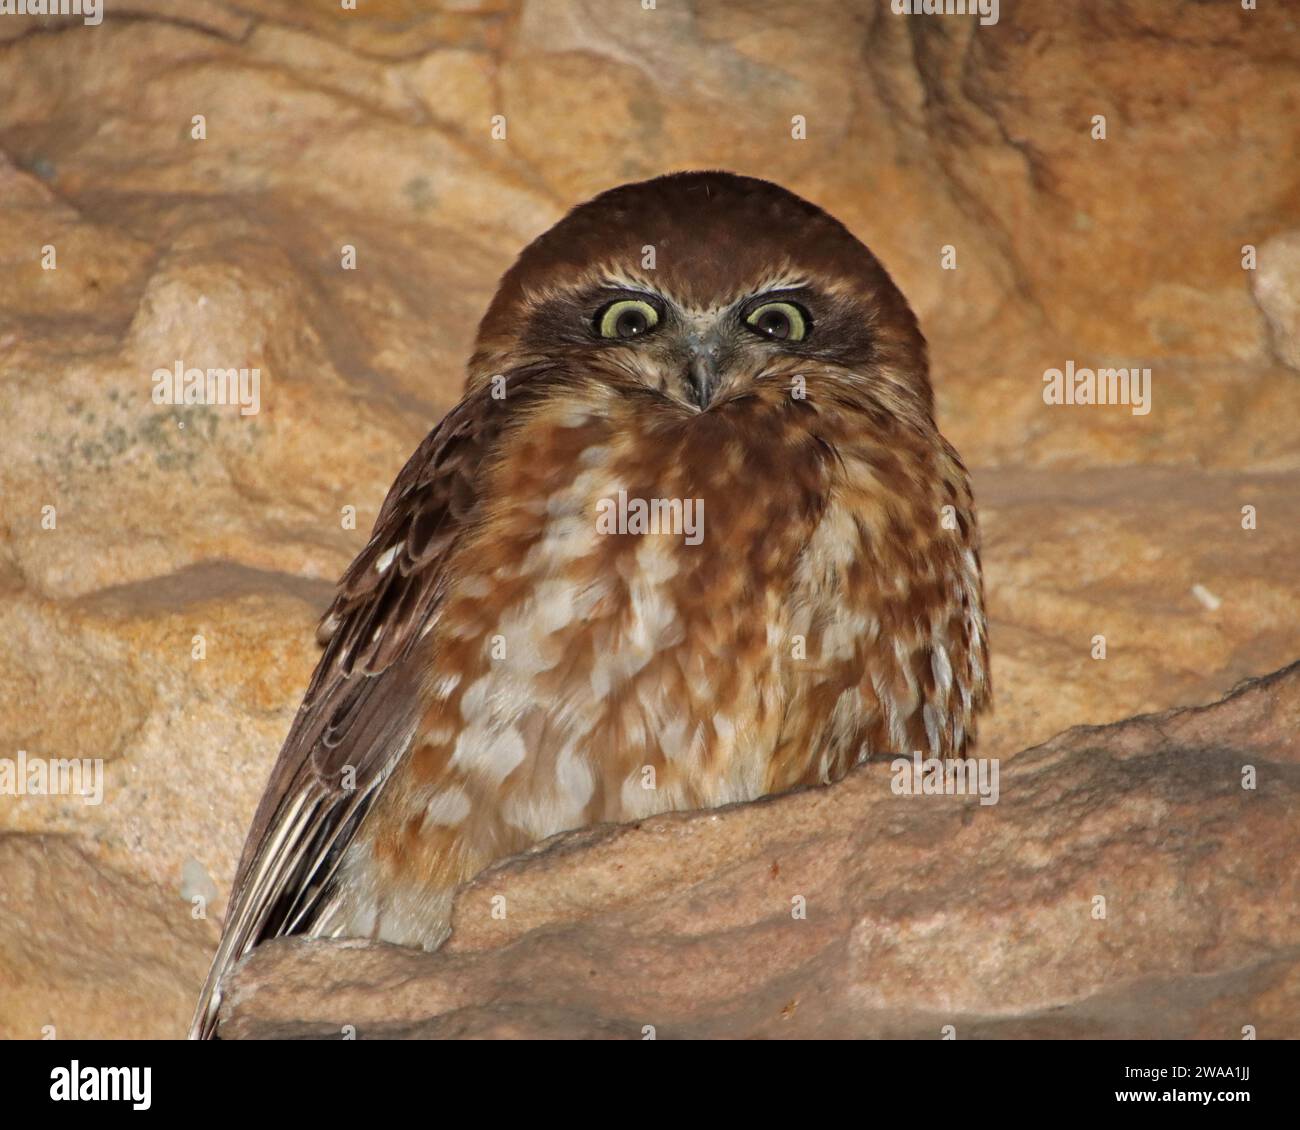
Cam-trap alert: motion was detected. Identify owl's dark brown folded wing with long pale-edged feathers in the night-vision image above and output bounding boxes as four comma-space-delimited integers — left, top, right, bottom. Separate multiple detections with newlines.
190, 371, 529, 1039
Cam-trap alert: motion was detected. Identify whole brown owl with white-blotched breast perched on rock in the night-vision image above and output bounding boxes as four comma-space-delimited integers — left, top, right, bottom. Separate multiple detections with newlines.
192, 172, 989, 1036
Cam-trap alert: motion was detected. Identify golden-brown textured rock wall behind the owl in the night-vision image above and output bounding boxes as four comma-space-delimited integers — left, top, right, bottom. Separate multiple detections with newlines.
0, 0, 1300, 1036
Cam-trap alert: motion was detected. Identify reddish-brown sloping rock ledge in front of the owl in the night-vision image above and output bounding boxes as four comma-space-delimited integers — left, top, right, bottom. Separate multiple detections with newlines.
221, 663, 1300, 1039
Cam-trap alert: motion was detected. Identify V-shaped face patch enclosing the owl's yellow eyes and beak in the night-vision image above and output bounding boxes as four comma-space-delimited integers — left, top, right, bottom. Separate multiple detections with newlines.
592, 291, 813, 411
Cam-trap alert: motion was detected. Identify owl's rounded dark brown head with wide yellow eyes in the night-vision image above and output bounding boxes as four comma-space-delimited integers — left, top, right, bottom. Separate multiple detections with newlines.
469, 172, 932, 416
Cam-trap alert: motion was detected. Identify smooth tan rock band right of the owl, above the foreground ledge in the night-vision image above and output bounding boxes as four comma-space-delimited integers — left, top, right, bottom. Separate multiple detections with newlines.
975, 467, 1300, 757
